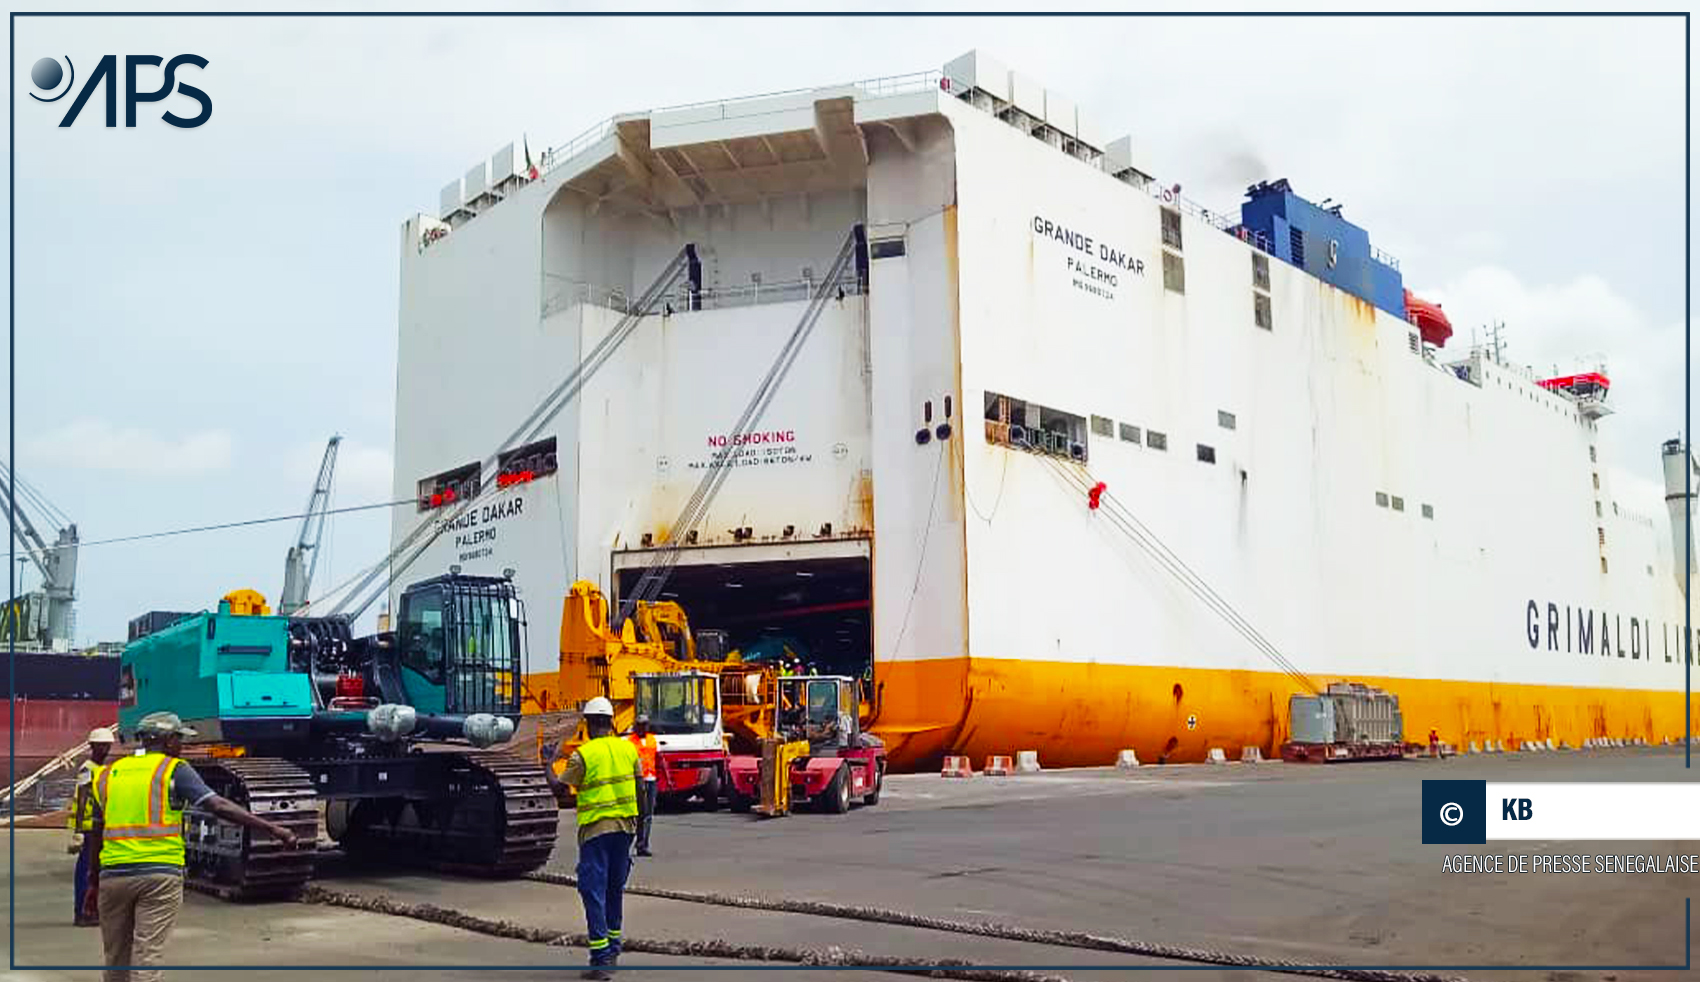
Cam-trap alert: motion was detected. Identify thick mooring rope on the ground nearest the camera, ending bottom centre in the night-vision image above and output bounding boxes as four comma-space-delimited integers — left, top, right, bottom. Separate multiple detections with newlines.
299, 885, 1068, 982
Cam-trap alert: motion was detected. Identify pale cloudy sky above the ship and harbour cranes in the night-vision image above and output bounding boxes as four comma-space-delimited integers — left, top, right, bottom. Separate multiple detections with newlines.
12, 17, 1685, 642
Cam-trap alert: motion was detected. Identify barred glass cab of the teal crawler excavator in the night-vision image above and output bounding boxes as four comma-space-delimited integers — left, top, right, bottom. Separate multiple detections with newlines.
391, 574, 525, 715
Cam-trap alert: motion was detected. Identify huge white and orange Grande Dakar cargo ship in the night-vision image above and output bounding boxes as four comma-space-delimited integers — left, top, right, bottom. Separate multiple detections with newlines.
391, 53, 1695, 768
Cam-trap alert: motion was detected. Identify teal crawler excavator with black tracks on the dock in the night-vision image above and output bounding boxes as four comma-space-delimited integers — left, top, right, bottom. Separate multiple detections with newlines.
119, 573, 559, 900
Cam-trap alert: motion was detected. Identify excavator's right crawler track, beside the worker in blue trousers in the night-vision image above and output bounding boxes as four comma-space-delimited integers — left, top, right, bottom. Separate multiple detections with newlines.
340, 751, 561, 878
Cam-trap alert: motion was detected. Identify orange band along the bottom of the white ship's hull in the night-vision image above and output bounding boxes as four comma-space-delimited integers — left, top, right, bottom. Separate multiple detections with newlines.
525, 657, 1700, 771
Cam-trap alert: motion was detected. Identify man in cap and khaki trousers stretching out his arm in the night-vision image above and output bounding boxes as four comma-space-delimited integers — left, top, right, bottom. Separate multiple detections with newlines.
83, 712, 296, 982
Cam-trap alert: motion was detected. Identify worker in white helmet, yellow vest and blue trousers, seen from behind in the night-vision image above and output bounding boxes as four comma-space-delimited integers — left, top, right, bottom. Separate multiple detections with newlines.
542, 695, 643, 980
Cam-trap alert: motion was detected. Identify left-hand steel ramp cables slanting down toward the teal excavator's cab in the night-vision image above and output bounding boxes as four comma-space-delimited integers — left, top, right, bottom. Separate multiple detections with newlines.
330, 245, 695, 620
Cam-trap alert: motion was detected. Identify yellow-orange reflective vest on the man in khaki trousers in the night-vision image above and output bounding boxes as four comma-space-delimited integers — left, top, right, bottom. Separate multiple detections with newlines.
95, 753, 184, 870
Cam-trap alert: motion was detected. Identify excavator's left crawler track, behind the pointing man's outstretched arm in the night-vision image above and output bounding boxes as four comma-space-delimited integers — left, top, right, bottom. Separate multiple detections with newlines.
184, 754, 320, 900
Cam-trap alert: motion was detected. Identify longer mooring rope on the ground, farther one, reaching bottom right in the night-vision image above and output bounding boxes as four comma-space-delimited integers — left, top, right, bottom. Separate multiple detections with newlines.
525, 870, 1465, 982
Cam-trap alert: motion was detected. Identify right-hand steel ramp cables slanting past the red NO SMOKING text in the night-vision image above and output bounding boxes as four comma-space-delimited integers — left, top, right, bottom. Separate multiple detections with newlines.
610, 226, 862, 630
